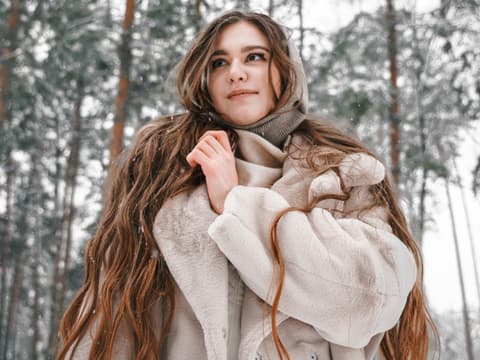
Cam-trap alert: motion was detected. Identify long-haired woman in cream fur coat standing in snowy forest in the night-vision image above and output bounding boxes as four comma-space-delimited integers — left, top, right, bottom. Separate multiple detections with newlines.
58, 11, 436, 360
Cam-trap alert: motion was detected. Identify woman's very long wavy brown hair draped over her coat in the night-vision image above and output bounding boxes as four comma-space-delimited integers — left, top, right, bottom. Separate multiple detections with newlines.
57, 11, 438, 360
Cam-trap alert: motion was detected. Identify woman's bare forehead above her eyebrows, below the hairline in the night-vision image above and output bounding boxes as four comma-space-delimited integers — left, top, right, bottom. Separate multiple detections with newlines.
214, 21, 270, 51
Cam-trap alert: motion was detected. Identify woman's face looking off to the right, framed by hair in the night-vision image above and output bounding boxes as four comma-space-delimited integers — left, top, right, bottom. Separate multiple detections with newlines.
208, 21, 280, 125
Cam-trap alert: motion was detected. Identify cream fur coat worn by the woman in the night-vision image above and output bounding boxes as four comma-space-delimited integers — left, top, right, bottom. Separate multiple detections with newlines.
70, 130, 416, 360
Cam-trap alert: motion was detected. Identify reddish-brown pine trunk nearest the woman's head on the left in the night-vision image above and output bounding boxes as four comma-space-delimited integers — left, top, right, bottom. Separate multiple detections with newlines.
110, 0, 135, 164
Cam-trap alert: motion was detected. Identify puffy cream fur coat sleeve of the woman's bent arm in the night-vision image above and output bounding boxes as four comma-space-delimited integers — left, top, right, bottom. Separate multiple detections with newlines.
209, 154, 416, 348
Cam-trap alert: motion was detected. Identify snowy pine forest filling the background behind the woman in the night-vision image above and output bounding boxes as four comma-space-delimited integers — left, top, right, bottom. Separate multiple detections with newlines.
0, 0, 480, 360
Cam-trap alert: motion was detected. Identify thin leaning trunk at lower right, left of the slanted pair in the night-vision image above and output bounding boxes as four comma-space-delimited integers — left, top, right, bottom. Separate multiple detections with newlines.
445, 179, 474, 360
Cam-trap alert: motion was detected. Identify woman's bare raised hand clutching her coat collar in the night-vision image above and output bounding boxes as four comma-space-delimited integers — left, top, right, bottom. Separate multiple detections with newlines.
187, 131, 238, 214
